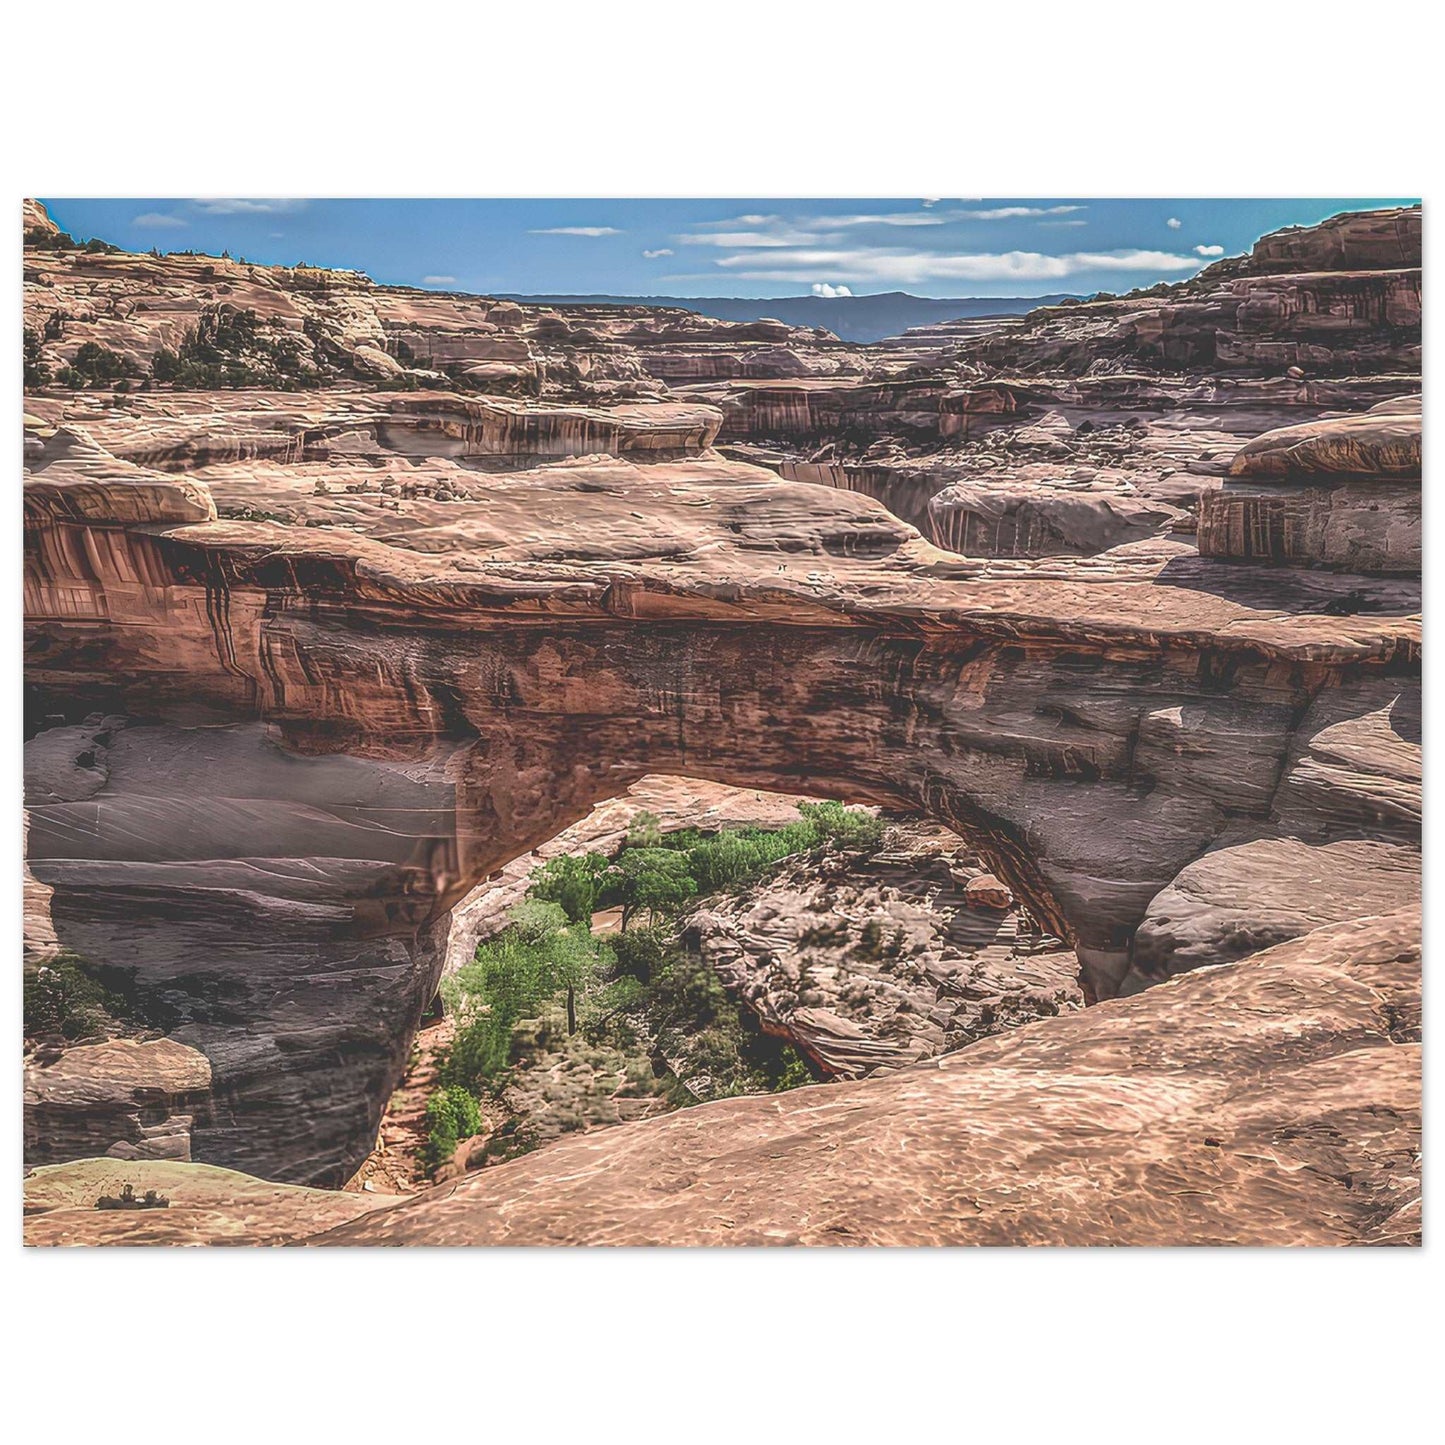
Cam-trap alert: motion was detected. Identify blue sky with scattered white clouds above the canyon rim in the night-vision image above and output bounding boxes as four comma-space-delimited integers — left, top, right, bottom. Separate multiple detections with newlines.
46, 198, 1406, 296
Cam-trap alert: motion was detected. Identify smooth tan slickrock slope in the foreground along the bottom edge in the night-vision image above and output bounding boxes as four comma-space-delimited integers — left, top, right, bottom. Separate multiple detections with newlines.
26, 912, 1420, 1246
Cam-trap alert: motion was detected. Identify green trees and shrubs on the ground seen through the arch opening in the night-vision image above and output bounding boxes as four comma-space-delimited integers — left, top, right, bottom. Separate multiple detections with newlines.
429, 802, 883, 1168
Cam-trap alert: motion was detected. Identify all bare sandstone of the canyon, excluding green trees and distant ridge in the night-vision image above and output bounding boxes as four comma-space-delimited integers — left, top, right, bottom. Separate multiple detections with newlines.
25, 202, 1422, 1246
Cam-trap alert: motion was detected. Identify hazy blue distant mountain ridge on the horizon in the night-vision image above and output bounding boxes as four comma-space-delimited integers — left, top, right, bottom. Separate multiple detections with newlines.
501, 290, 1068, 342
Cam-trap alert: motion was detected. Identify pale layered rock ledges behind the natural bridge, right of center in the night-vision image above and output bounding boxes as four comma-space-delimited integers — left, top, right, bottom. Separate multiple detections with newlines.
751, 373, 1418, 558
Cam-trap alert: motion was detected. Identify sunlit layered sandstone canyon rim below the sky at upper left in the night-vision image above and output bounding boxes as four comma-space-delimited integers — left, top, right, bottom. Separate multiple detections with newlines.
25, 201, 841, 400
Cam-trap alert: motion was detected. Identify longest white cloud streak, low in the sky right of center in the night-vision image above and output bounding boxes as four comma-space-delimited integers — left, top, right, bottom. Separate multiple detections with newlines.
714, 247, 1199, 285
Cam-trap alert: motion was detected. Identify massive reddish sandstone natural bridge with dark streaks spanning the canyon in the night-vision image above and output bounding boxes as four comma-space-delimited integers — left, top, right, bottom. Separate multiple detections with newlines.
26, 434, 1418, 1183
